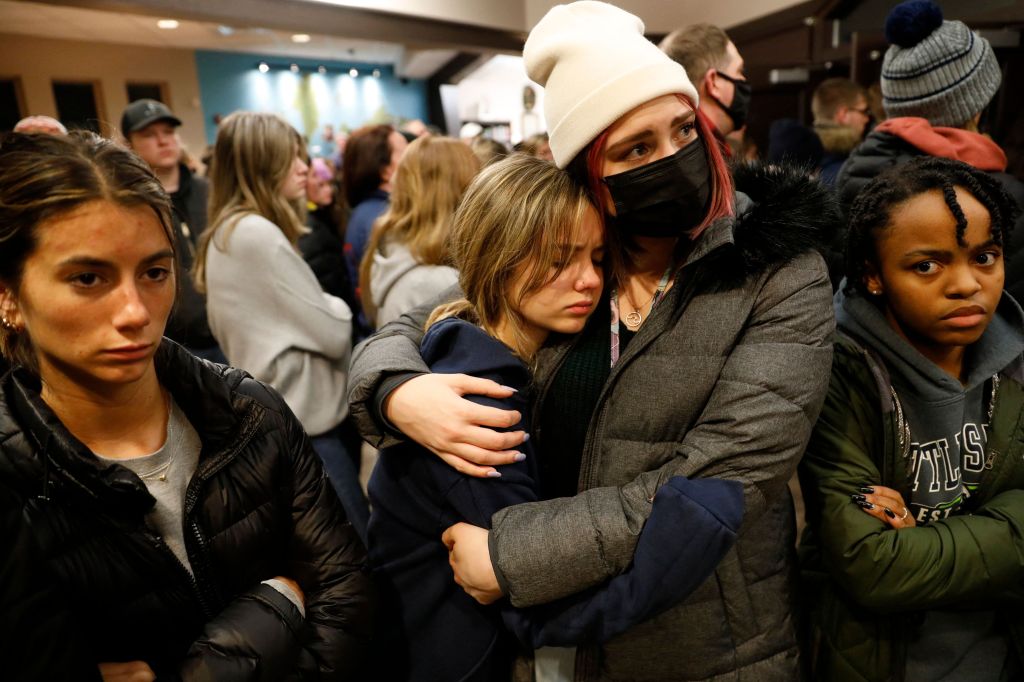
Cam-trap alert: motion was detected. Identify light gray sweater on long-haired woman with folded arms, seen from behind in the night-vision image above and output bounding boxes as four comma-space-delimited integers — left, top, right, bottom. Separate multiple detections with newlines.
206, 214, 352, 435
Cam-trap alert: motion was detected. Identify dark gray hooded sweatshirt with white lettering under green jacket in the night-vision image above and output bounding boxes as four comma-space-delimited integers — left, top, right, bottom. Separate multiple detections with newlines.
835, 288, 1024, 682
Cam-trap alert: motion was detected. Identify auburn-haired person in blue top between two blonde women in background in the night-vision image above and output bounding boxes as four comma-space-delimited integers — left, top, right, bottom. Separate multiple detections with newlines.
342, 125, 409, 311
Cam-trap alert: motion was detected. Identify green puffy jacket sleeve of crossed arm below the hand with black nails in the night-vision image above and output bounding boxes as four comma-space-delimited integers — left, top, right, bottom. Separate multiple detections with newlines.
801, 339, 1024, 612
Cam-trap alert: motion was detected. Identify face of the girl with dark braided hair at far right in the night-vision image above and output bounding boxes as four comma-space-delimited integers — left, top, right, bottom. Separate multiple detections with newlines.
865, 187, 1004, 358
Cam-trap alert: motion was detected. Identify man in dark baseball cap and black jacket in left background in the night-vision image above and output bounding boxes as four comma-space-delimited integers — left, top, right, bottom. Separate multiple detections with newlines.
121, 99, 227, 363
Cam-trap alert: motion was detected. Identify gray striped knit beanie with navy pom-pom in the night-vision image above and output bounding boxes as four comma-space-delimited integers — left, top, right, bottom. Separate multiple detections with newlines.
882, 0, 1002, 126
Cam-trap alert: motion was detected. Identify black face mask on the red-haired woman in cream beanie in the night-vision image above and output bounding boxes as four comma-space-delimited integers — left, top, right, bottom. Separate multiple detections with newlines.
604, 140, 711, 237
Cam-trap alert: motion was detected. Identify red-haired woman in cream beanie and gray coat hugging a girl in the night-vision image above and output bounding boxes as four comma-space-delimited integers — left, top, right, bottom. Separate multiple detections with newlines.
349, 1, 837, 681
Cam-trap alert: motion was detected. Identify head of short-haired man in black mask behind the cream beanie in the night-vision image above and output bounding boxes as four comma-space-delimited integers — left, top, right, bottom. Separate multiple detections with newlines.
658, 24, 751, 150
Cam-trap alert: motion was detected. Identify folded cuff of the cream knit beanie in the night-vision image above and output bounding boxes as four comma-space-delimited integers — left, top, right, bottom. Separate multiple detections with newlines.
548, 59, 698, 168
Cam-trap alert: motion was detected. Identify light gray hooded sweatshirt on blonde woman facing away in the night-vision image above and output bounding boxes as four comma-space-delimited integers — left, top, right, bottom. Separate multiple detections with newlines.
370, 242, 459, 328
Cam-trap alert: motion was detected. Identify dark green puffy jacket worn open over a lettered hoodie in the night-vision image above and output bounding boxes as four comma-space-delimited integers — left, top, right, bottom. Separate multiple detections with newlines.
800, 334, 1024, 682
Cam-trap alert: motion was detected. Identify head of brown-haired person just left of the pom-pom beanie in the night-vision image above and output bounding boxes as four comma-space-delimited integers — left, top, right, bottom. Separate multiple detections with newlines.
811, 78, 871, 187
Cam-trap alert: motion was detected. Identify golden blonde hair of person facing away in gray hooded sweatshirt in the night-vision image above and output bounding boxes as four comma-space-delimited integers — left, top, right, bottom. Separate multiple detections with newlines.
359, 135, 480, 321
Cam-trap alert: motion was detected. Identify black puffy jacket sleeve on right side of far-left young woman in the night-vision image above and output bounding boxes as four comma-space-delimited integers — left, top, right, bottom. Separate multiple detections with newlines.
180, 382, 375, 682
